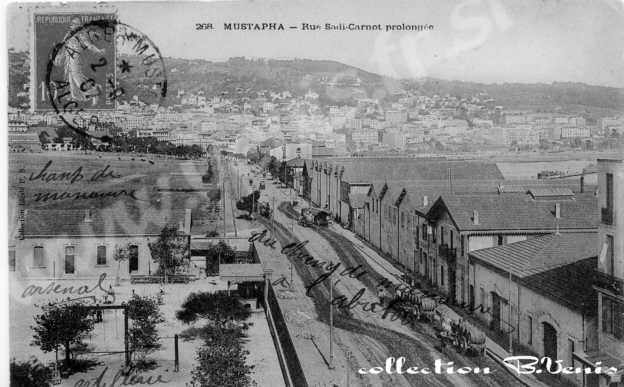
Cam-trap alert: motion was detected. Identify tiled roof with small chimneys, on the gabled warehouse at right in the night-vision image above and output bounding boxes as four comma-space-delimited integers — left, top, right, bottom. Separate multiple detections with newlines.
427, 193, 598, 231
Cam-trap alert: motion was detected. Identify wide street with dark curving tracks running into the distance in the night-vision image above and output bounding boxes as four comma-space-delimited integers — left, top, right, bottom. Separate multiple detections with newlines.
225, 158, 521, 386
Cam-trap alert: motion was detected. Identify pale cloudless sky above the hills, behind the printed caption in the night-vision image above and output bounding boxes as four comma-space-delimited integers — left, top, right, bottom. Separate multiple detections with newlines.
8, 0, 624, 87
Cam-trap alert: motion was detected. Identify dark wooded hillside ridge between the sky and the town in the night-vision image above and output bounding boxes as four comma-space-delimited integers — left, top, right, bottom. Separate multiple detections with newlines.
9, 51, 624, 116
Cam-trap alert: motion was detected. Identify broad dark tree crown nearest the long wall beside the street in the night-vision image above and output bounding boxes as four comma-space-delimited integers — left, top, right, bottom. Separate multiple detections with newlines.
176, 292, 251, 329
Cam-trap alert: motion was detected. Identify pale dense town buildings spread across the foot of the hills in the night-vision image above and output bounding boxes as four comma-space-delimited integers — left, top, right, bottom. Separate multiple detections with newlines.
9, 78, 624, 156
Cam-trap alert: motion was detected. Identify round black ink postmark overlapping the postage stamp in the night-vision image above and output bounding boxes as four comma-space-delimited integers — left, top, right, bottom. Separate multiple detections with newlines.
45, 17, 167, 141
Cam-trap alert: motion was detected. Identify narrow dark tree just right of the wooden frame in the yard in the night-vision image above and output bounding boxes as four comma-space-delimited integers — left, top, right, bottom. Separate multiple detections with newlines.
126, 294, 165, 368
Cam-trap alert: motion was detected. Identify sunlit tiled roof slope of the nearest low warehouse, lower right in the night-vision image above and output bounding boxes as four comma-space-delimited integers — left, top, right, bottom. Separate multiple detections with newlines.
470, 232, 598, 278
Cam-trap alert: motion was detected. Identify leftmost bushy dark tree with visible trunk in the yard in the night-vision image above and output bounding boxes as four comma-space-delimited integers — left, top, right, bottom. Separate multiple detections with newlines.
31, 302, 94, 369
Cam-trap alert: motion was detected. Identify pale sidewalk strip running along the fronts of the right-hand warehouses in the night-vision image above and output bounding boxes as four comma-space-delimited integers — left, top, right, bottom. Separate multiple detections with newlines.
330, 224, 548, 387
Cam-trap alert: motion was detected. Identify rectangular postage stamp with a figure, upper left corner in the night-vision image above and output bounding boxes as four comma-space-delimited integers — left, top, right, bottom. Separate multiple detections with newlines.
32, 13, 116, 112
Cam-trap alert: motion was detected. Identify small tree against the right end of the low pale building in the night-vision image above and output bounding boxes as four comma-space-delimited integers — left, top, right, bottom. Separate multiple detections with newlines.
149, 225, 189, 275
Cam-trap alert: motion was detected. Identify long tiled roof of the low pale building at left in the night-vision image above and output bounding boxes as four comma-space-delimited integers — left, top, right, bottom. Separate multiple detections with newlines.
24, 207, 185, 237
